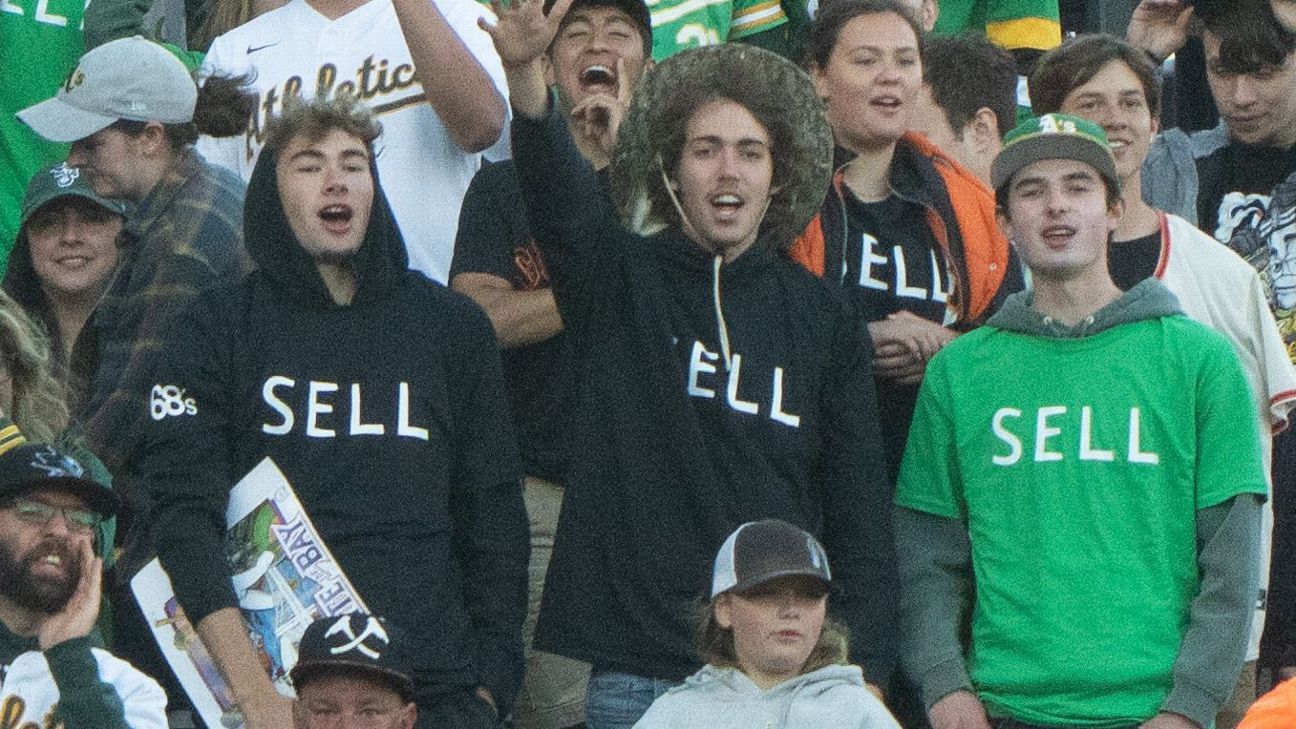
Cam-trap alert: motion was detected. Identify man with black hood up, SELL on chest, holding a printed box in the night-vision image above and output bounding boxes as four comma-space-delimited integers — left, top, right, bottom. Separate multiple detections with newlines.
145, 99, 527, 729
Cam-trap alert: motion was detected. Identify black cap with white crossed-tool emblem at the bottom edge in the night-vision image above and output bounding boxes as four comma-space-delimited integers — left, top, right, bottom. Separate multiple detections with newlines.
289, 612, 413, 702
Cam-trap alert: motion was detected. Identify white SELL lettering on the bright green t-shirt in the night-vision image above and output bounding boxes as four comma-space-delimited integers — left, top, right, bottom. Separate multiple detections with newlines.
990, 405, 1161, 467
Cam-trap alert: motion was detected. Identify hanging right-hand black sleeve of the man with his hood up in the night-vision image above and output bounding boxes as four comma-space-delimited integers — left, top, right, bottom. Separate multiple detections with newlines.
450, 304, 530, 711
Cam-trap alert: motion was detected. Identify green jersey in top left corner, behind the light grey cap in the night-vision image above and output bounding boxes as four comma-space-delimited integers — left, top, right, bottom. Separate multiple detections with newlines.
0, 0, 86, 275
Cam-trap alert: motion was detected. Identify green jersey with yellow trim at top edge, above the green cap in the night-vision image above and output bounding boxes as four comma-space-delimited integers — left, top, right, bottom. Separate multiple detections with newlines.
933, 0, 1061, 51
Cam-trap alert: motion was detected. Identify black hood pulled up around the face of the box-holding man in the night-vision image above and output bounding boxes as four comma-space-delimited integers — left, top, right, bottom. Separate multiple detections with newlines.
244, 142, 410, 306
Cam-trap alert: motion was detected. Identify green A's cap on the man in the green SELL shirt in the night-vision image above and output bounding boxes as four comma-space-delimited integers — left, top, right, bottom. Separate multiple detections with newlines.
990, 114, 1121, 189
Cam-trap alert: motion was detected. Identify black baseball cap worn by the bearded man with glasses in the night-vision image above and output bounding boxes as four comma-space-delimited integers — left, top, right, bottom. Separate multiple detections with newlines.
0, 433, 121, 516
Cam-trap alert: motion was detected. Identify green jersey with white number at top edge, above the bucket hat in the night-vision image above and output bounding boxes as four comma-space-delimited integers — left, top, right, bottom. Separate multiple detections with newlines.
648, 0, 788, 61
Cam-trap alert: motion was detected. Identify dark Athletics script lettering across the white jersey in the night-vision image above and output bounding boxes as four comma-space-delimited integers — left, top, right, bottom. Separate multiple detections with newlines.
245, 54, 424, 162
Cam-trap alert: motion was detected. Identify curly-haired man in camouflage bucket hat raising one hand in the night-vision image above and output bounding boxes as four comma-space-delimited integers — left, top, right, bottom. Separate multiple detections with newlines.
491, 0, 896, 729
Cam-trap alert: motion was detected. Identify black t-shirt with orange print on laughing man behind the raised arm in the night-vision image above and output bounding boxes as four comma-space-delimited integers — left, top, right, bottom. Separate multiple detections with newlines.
450, 161, 568, 481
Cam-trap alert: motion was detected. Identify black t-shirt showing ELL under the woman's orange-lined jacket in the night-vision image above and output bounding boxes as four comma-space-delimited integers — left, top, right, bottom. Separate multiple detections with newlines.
844, 189, 953, 477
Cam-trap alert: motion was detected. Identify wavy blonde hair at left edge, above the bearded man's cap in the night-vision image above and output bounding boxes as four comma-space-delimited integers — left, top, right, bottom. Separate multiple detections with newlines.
0, 292, 69, 442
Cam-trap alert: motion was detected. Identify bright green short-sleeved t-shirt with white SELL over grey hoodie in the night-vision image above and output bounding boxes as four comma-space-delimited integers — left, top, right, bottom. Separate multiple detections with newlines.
896, 317, 1265, 726
